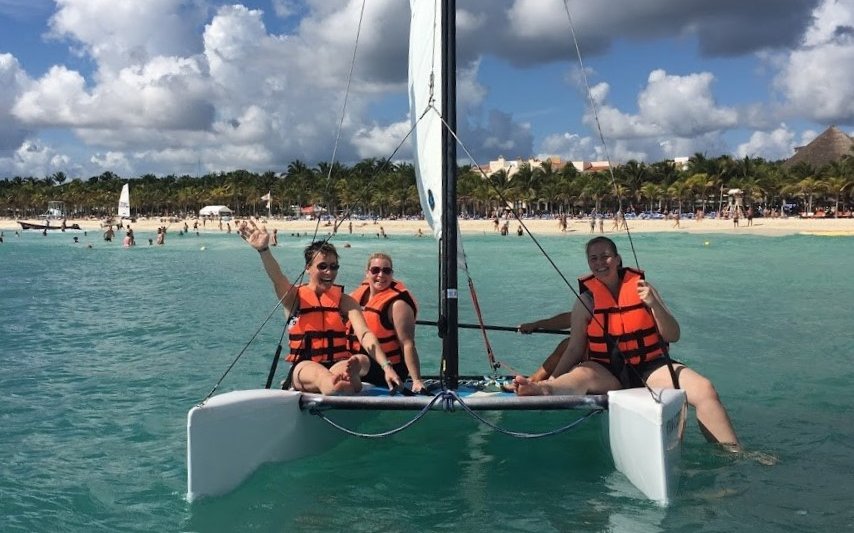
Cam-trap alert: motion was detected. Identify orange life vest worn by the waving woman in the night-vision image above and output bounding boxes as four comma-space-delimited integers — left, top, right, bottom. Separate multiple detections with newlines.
286, 285, 351, 365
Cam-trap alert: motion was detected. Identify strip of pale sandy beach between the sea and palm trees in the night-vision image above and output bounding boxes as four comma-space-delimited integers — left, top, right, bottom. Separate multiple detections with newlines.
0, 217, 854, 237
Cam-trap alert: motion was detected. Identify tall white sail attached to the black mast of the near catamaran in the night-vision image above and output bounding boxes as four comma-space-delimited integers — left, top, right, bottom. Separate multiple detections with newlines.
409, 0, 443, 239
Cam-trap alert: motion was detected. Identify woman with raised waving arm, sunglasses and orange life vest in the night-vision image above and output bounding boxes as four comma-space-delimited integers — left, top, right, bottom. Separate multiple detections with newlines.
239, 221, 401, 395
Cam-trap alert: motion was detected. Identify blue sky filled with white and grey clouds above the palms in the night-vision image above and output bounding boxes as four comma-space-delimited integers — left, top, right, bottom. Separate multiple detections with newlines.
0, 0, 854, 178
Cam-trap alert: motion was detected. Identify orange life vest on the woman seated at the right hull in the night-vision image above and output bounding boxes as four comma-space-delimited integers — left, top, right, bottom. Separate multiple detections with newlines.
578, 268, 666, 365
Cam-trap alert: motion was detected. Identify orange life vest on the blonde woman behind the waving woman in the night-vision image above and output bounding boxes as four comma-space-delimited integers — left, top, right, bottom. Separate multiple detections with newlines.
350, 281, 418, 365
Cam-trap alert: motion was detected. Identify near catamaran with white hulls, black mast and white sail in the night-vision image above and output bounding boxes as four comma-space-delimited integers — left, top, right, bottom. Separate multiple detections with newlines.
187, 0, 685, 503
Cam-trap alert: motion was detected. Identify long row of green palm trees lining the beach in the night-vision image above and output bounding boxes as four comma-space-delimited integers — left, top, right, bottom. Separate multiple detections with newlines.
0, 152, 854, 218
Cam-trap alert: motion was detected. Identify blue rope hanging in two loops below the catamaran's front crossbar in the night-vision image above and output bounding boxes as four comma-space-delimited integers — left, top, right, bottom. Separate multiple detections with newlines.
304, 389, 605, 439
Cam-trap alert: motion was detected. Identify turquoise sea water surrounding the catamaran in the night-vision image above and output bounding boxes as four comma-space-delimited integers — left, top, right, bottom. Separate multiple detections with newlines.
0, 227, 854, 532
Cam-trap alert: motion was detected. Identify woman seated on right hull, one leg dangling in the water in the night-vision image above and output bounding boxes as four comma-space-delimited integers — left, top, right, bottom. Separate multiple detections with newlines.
514, 237, 740, 451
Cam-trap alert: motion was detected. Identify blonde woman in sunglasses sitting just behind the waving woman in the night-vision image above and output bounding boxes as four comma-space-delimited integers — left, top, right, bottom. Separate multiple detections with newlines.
350, 252, 424, 392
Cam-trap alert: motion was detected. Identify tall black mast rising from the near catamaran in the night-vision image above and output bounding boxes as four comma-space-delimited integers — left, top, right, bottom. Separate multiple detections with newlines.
440, 0, 459, 389
